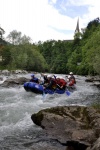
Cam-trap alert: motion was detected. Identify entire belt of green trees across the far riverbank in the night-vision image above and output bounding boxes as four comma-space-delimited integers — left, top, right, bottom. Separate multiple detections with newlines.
0, 18, 100, 75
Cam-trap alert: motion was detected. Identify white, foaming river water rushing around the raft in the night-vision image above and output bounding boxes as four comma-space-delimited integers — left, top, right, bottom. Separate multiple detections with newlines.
0, 74, 100, 150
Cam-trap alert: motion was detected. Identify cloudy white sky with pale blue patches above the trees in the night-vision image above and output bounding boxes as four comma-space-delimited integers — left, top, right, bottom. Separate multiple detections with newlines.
0, 0, 100, 43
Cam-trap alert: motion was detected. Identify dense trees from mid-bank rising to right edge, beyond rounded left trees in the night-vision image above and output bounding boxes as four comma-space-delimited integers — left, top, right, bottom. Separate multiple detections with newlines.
39, 18, 100, 75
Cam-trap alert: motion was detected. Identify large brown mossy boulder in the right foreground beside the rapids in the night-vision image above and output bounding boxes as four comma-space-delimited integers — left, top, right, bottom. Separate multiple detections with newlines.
31, 106, 100, 150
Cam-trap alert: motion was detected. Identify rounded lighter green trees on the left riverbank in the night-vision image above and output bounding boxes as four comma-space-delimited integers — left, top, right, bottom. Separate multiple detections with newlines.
1, 44, 48, 72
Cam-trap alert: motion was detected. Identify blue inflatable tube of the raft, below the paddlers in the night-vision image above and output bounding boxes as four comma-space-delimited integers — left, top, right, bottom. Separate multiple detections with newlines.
24, 82, 65, 94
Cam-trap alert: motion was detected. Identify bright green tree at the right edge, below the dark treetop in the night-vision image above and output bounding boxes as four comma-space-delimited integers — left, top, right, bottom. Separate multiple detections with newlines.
80, 26, 100, 74
